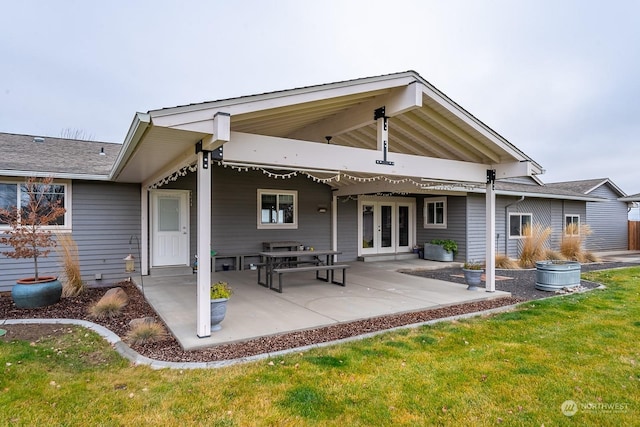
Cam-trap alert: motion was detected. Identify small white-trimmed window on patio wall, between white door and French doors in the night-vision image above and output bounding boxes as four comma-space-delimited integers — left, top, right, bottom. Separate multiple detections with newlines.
258, 189, 298, 229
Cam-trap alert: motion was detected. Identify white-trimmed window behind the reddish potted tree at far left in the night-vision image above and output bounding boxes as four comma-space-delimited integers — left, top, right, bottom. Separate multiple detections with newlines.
0, 181, 71, 230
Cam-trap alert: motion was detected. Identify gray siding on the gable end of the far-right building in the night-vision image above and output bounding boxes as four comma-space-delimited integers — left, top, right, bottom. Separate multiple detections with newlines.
581, 185, 629, 251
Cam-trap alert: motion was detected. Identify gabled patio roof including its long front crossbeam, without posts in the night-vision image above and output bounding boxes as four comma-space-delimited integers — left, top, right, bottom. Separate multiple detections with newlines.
112, 71, 542, 186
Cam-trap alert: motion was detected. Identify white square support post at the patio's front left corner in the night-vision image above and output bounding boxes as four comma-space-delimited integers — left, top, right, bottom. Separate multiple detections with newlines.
196, 151, 211, 338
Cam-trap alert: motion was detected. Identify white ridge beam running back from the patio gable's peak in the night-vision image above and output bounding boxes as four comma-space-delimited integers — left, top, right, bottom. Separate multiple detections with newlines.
288, 82, 423, 141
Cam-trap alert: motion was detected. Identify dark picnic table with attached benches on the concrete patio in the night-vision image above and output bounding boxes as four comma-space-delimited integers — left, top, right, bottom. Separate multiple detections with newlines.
258, 249, 349, 292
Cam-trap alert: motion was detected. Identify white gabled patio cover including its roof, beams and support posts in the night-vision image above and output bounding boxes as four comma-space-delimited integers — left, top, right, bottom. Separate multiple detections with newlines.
111, 71, 543, 338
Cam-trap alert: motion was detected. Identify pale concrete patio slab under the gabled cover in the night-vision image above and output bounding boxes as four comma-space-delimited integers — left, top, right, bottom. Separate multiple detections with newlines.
144, 259, 509, 350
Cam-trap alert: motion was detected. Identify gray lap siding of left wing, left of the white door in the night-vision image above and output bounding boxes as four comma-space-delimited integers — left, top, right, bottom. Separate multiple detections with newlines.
0, 181, 140, 291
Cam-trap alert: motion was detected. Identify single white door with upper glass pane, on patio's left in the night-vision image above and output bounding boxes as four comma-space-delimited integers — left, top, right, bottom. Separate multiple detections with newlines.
151, 190, 189, 267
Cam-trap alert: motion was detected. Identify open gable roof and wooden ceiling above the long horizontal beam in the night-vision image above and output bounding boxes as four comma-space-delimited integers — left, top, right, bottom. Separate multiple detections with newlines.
114, 72, 542, 187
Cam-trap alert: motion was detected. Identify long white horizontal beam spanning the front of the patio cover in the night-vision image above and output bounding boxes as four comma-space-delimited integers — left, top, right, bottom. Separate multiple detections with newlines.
223, 132, 489, 183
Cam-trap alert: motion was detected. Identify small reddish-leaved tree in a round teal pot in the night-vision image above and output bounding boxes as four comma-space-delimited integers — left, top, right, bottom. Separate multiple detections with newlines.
0, 177, 66, 308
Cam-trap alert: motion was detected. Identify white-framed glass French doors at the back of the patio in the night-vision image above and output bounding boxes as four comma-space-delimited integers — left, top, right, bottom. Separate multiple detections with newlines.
358, 197, 415, 255
